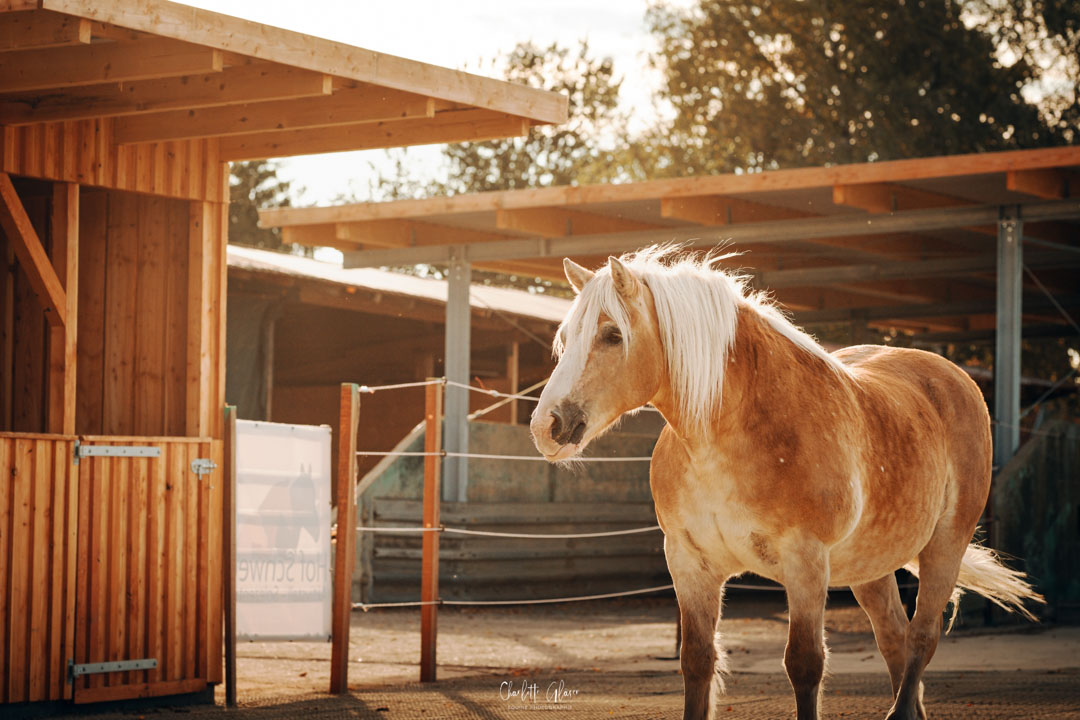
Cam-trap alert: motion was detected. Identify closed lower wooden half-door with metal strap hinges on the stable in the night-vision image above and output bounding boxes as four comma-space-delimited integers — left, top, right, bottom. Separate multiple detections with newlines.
75, 437, 222, 703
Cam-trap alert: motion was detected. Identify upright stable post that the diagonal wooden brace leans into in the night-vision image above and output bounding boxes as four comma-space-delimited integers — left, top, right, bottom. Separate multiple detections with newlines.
46, 182, 79, 435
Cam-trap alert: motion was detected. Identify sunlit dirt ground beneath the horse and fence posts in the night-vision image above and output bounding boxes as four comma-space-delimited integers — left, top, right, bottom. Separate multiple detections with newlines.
44, 596, 1080, 720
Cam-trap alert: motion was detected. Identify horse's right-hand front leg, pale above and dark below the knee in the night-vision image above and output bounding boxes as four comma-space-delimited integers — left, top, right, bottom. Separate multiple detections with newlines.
783, 541, 828, 720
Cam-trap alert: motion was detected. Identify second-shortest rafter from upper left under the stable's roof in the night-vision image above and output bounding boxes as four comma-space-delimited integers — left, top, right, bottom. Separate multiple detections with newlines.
0, 38, 224, 93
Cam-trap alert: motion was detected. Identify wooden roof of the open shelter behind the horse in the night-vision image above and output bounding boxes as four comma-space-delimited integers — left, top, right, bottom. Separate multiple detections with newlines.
260, 147, 1080, 339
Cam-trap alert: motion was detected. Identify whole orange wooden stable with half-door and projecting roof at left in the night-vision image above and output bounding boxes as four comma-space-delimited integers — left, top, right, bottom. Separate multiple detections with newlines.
0, 0, 566, 715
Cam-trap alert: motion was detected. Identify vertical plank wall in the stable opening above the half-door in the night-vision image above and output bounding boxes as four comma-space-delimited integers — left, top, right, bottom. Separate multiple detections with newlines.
76, 191, 227, 437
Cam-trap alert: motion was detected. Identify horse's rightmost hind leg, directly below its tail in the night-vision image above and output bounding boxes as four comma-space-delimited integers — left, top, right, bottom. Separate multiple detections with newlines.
886, 518, 971, 720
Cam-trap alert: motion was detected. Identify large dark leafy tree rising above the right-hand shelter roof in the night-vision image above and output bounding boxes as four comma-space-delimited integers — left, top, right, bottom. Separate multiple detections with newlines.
635, 0, 1063, 175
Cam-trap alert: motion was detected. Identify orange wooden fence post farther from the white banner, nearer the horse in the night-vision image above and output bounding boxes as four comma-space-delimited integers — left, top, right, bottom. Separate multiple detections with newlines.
420, 378, 444, 682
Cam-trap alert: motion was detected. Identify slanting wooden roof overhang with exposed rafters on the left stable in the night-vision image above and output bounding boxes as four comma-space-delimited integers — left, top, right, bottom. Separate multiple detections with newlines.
0, 0, 567, 165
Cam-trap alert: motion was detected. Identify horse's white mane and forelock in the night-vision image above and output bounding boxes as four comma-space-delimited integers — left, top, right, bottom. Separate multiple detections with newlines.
554, 245, 848, 425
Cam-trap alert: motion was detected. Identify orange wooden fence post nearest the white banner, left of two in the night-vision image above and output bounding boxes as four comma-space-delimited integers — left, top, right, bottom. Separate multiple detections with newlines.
330, 382, 360, 694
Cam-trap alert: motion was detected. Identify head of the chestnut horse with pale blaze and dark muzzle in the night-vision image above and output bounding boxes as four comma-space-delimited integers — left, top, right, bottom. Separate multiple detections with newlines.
531, 258, 664, 461
